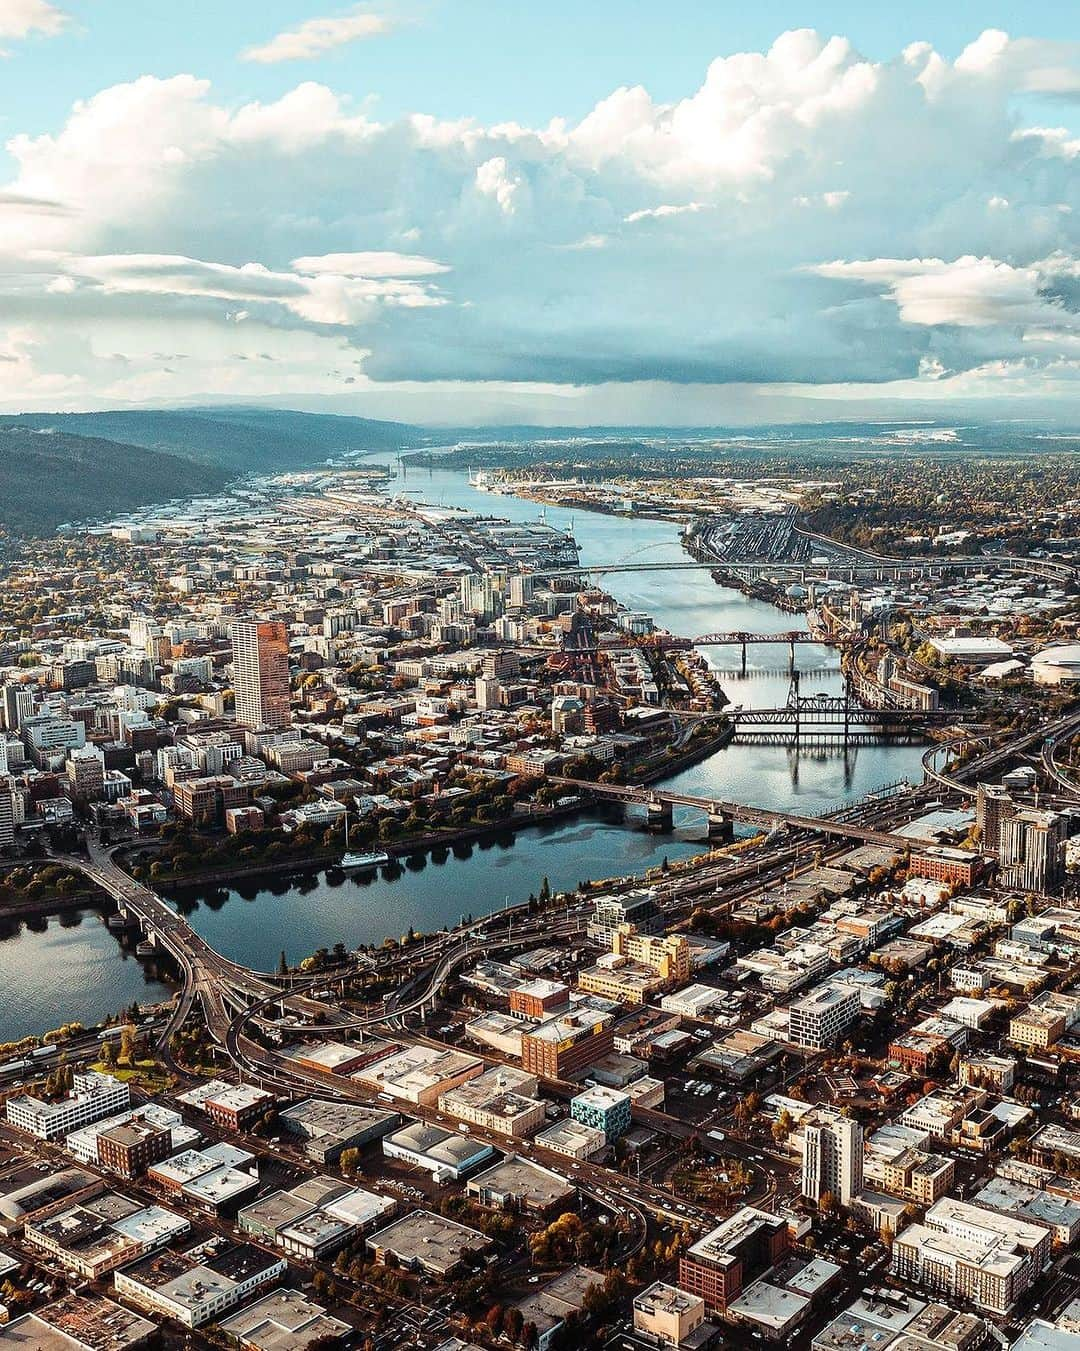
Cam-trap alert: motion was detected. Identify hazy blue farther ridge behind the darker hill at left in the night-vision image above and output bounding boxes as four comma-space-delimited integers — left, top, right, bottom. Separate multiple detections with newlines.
9, 408, 437, 474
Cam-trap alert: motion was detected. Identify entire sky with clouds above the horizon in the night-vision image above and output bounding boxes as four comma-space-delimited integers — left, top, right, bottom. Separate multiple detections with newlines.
0, 0, 1080, 424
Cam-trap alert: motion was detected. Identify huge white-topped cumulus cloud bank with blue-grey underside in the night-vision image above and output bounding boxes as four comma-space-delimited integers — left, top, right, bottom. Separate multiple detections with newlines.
0, 31, 1080, 407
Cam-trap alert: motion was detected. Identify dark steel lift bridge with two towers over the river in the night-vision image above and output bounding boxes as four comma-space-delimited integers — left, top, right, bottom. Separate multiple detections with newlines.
725, 670, 956, 747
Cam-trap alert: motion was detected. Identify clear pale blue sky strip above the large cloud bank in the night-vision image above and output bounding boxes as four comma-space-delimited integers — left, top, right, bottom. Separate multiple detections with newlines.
12, 0, 1077, 131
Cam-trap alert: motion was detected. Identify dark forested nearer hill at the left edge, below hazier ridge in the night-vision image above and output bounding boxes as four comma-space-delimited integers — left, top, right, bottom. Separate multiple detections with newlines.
0, 429, 232, 535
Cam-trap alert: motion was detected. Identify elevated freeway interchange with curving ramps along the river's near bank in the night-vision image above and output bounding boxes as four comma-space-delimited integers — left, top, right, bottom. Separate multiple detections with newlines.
42, 713, 1080, 1329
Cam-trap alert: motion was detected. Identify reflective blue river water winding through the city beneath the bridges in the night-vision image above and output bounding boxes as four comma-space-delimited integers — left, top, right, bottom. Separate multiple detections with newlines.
0, 469, 922, 1039
